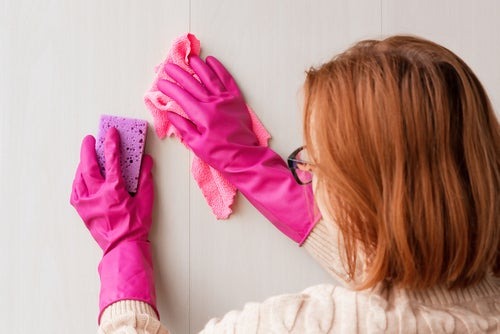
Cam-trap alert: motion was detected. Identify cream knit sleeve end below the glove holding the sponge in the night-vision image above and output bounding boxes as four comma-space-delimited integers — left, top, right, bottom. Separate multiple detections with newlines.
97, 300, 170, 334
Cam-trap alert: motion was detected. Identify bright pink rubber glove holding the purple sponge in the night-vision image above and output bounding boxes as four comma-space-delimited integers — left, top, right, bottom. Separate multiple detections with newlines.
70, 128, 158, 322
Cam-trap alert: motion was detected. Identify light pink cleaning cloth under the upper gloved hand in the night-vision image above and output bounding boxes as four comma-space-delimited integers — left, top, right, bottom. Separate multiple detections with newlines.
144, 33, 271, 219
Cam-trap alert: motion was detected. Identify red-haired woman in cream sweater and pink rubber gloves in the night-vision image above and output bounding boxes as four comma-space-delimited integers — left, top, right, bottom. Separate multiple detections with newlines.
71, 36, 500, 333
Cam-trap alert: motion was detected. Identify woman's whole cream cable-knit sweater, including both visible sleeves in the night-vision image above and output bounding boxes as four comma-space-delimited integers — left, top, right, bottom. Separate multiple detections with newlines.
98, 221, 500, 334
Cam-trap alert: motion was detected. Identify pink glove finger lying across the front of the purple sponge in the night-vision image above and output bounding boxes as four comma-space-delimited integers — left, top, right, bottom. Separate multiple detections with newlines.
104, 127, 124, 187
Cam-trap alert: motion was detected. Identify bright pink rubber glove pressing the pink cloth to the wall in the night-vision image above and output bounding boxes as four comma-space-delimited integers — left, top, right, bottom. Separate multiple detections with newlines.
158, 56, 320, 244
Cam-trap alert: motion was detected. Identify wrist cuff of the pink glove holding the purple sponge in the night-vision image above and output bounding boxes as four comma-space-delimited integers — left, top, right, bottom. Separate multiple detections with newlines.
98, 241, 159, 323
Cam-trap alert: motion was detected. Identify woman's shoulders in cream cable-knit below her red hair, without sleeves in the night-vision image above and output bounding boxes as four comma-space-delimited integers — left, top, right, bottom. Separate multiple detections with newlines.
203, 280, 500, 333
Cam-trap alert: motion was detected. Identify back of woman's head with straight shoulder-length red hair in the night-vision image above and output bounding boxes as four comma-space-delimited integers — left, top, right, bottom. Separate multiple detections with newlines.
304, 36, 500, 289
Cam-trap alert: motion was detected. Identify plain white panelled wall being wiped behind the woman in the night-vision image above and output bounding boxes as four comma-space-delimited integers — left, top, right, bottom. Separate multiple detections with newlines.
0, 0, 500, 334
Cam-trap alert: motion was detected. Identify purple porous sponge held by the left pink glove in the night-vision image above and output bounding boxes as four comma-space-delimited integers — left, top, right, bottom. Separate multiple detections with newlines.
96, 115, 148, 193
